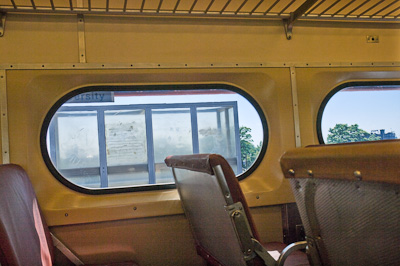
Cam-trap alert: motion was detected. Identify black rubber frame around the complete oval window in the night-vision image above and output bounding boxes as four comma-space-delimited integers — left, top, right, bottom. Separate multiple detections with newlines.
40, 83, 269, 195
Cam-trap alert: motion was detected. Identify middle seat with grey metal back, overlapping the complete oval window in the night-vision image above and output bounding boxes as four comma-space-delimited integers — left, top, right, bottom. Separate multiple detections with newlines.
165, 154, 309, 266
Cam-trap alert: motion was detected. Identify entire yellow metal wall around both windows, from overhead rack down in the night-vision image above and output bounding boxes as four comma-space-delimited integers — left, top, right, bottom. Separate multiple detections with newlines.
0, 7, 400, 265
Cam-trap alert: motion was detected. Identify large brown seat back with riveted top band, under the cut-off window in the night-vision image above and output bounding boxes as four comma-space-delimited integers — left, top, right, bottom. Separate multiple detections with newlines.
281, 140, 400, 265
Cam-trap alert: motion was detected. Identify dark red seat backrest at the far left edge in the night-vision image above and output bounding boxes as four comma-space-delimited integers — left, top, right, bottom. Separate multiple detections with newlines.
0, 164, 53, 266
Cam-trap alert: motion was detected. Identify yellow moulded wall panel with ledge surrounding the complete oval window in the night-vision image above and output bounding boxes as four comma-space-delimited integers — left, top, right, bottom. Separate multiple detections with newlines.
8, 68, 294, 225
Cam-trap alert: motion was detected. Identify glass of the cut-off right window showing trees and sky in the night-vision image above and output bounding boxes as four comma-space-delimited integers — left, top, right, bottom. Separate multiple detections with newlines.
320, 85, 400, 144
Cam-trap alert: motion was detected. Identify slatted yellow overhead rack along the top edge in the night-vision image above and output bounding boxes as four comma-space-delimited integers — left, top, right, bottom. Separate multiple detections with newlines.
0, 0, 400, 22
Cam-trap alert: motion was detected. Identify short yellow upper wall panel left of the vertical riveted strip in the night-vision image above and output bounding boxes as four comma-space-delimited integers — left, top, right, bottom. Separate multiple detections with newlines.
0, 14, 79, 64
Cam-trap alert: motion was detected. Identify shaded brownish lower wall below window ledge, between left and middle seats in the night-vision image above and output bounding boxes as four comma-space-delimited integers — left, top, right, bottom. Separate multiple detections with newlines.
52, 215, 205, 266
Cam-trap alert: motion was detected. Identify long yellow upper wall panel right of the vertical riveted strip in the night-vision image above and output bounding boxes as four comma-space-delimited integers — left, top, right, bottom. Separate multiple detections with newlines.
85, 16, 400, 63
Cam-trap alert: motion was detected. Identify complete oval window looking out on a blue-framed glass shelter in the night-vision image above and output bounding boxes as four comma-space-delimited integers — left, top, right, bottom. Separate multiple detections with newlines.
41, 85, 267, 193
